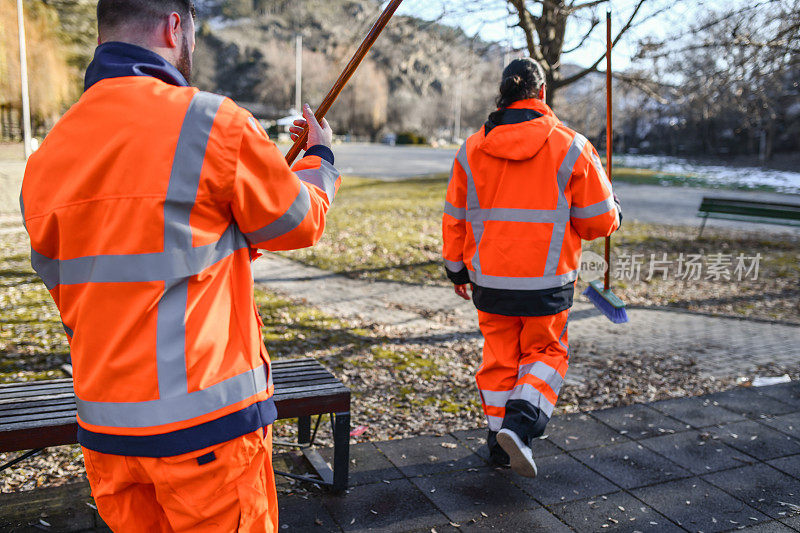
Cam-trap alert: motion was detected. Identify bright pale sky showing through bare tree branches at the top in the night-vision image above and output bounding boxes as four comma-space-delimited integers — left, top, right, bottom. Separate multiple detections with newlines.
398, 0, 724, 69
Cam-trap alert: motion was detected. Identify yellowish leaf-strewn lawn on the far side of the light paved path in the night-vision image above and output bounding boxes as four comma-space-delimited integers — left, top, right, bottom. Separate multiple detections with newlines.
285, 177, 800, 322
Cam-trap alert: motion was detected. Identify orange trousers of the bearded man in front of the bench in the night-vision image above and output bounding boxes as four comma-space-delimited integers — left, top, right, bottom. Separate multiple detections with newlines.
83, 426, 278, 533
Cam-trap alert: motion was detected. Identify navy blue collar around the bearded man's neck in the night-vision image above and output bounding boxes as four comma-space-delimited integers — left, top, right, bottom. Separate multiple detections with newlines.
84, 42, 189, 91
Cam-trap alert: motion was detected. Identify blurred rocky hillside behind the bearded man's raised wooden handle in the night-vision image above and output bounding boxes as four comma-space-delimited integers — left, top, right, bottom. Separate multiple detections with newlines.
195, 0, 502, 138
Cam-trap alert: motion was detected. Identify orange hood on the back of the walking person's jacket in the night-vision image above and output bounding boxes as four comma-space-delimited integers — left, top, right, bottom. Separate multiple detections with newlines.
478, 98, 561, 161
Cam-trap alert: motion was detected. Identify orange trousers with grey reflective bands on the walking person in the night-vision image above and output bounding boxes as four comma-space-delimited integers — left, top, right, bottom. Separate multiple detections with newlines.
475, 309, 569, 441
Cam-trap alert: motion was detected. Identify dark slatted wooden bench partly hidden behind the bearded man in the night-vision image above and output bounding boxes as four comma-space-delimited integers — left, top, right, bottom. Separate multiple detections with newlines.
0, 359, 350, 492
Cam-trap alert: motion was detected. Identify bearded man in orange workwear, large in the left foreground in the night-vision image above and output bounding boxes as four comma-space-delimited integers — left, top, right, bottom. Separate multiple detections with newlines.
20, 0, 341, 532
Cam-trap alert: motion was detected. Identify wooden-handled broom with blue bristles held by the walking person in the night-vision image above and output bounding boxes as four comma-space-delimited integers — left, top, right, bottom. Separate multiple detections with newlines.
583, 7, 628, 324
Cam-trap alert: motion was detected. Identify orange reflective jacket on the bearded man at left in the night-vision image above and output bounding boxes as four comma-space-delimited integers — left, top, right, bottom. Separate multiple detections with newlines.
21, 43, 340, 457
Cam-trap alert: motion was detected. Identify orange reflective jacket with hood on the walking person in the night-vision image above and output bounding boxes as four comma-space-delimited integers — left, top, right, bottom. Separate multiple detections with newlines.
442, 99, 620, 316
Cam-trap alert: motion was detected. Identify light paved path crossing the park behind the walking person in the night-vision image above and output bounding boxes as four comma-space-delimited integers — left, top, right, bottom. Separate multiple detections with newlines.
253, 254, 800, 377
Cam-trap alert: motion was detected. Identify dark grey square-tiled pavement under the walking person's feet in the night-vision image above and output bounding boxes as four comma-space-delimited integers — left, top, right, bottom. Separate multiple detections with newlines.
279, 383, 800, 533
